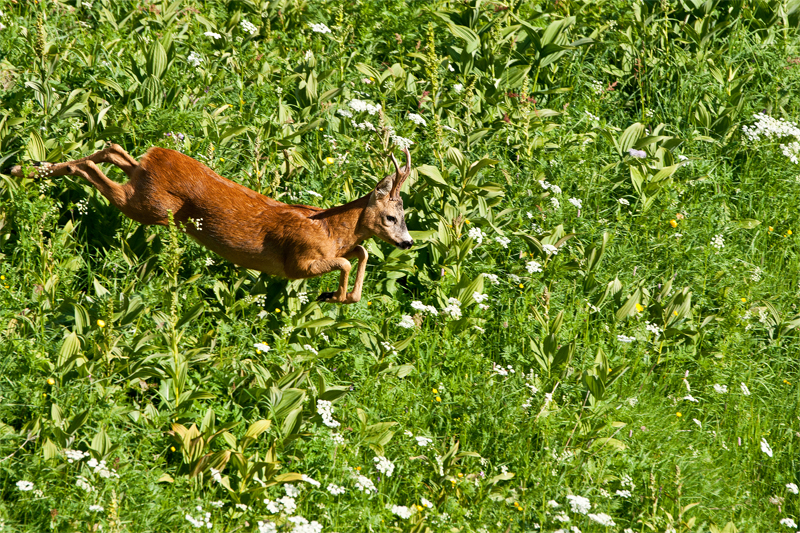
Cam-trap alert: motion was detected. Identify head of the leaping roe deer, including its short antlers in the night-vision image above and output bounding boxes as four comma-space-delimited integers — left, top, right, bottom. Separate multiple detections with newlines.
362, 148, 414, 250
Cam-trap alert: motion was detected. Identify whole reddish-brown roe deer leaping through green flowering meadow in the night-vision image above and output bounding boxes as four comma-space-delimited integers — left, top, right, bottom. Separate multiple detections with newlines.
11, 144, 414, 304
